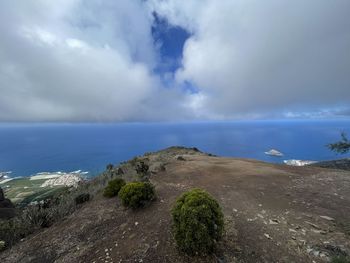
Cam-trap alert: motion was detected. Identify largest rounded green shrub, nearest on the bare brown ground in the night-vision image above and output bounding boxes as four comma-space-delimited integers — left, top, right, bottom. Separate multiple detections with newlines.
171, 189, 224, 255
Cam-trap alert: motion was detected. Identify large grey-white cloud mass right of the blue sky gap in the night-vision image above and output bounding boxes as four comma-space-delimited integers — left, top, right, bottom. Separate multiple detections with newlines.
151, 0, 350, 118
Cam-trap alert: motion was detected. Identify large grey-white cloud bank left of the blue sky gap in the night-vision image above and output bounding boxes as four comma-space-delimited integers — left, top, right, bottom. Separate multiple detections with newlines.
0, 0, 193, 121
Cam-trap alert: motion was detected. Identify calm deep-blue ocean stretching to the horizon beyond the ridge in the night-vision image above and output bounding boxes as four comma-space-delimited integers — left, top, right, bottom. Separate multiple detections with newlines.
0, 121, 350, 176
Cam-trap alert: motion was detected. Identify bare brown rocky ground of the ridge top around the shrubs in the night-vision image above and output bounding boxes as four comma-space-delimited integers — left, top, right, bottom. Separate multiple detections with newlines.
0, 148, 350, 263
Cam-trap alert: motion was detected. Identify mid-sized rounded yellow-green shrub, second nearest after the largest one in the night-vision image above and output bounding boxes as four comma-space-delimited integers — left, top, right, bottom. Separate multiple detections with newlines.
118, 182, 155, 208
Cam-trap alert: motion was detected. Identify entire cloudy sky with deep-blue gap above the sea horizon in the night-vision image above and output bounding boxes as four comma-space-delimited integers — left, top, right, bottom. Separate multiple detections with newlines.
0, 0, 350, 122
